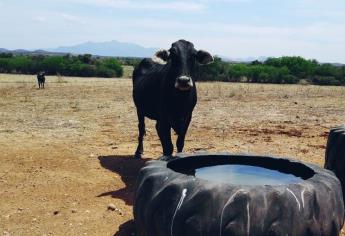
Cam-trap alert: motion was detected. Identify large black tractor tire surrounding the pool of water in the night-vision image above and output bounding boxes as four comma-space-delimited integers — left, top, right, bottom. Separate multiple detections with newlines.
134, 154, 344, 236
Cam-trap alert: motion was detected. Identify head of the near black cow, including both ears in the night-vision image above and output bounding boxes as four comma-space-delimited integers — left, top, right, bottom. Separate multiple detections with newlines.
152, 40, 213, 91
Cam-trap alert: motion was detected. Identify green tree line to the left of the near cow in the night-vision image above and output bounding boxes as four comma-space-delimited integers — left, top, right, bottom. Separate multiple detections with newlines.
0, 53, 123, 78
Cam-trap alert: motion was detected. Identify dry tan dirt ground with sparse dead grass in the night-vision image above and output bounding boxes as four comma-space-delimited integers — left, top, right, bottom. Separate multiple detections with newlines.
0, 75, 345, 235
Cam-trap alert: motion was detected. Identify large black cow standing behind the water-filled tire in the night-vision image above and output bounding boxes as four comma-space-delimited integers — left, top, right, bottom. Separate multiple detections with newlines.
133, 40, 213, 158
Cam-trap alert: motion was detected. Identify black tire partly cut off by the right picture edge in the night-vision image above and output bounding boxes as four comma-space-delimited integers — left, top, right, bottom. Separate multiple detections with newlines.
325, 126, 345, 206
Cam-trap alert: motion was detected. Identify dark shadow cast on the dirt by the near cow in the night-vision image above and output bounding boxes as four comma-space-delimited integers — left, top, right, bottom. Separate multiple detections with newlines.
97, 156, 151, 205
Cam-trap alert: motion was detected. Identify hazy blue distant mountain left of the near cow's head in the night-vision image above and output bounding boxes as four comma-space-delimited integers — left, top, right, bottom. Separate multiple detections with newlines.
46, 40, 157, 57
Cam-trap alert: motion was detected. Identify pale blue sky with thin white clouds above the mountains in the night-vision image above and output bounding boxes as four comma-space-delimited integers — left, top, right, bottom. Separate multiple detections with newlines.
0, 0, 345, 63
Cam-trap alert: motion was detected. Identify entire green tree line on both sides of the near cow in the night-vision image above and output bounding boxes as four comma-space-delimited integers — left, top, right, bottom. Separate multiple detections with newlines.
0, 53, 345, 85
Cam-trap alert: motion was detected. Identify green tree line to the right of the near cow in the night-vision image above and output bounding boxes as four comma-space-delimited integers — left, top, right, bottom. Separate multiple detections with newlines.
199, 56, 345, 85
